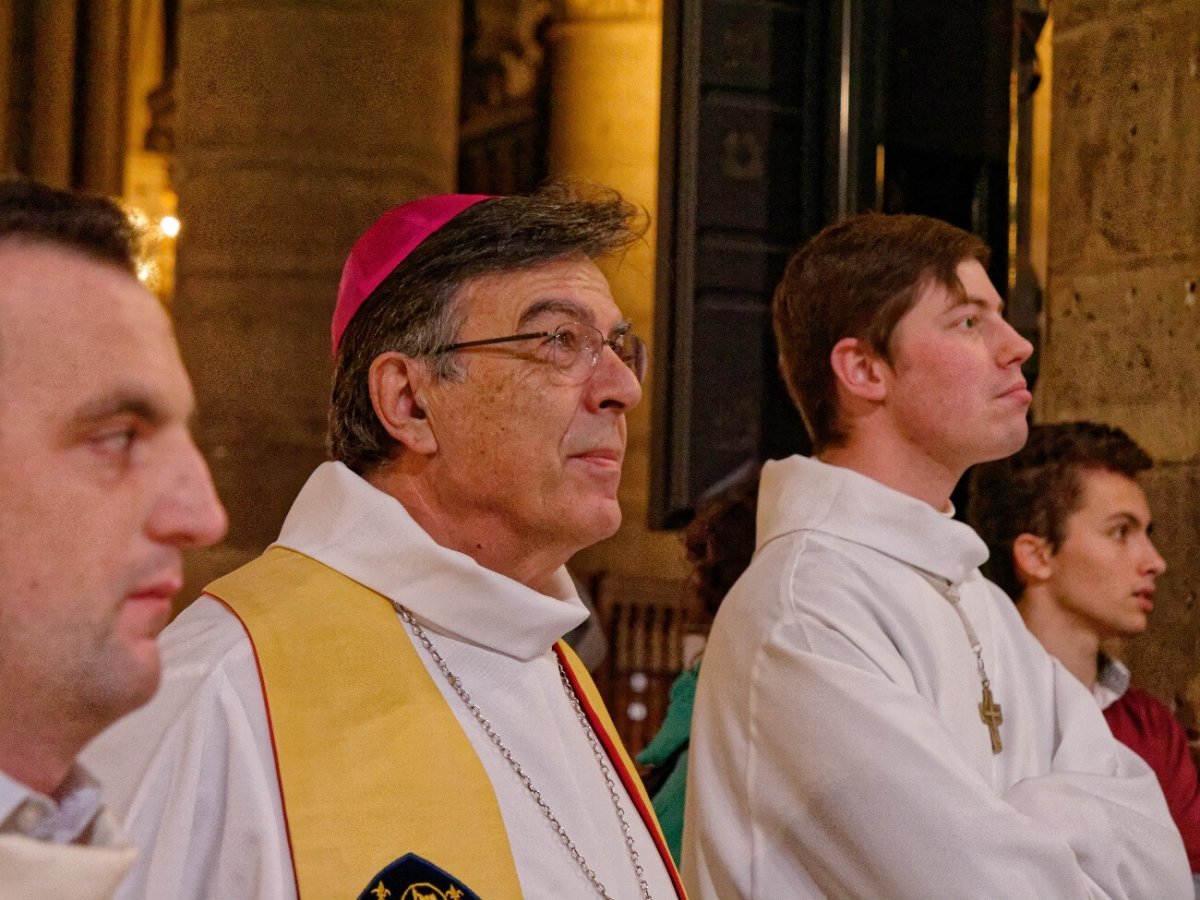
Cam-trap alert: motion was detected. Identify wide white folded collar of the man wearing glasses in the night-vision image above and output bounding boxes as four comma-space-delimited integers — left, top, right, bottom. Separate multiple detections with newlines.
276, 462, 588, 660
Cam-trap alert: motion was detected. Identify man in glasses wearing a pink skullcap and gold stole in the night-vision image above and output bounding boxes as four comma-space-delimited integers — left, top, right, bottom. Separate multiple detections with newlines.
89, 186, 678, 900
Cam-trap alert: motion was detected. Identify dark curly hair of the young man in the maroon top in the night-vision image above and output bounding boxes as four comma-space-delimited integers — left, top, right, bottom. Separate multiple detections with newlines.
967, 422, 1153, 600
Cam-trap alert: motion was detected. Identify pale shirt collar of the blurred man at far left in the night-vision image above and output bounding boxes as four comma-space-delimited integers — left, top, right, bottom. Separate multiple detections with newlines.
0, 766, 101, 844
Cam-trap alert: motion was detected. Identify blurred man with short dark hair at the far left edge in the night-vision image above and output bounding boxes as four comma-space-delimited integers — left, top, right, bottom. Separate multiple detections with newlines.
0, 180, 226, 900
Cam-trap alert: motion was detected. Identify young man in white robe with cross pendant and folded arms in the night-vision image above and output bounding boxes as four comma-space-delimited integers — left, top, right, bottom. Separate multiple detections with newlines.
683, 214, 1192, 900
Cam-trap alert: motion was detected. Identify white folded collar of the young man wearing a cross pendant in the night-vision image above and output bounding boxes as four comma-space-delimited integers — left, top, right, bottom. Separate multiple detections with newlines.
757, 456, 988, 584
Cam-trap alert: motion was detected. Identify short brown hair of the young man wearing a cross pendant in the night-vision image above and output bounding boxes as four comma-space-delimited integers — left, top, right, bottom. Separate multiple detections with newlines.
772, 212, 988, 452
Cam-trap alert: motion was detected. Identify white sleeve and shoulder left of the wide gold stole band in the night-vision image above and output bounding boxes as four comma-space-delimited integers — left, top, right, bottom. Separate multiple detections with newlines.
84, 598, 296, 900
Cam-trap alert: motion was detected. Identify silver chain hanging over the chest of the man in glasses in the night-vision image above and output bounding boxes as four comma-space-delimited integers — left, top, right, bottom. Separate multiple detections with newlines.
391, 600, 652, 900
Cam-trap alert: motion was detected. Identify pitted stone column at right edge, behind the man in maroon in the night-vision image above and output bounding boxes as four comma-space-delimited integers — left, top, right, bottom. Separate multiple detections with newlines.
1034, 0, 1200, 701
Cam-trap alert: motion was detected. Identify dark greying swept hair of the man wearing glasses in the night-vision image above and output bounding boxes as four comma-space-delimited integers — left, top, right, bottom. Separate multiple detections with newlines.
329, 182, 644, 474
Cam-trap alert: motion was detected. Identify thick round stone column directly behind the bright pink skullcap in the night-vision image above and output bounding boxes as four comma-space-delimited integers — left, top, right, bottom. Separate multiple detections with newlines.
174, 0, 462, 607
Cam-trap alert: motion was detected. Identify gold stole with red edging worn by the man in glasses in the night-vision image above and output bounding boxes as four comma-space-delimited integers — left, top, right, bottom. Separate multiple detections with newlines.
205, 547, 684, 900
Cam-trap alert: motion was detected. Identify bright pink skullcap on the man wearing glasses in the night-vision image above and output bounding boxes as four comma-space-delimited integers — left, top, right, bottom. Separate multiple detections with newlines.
332, 193, 492, 355
